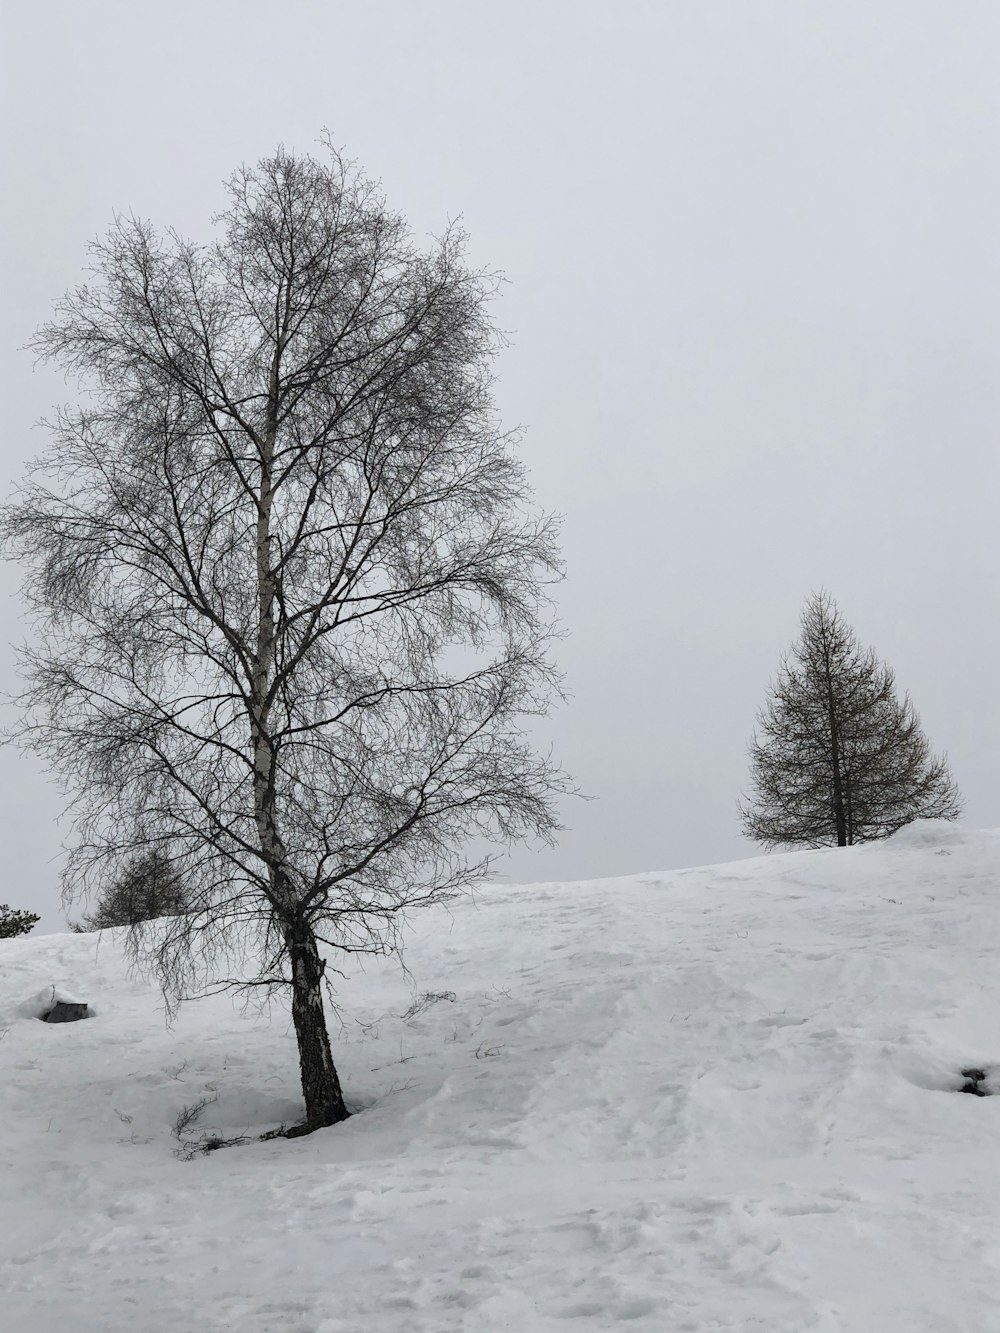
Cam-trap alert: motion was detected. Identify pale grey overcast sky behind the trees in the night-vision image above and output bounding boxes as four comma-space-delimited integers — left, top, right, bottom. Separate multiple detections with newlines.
0, 0, 1000, 929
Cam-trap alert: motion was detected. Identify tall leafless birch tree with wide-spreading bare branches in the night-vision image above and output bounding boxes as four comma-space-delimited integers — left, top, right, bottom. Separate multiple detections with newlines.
4, 149, 564, 1132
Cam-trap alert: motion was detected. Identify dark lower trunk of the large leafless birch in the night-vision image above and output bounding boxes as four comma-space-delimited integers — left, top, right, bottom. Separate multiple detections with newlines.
285, 925, 351, 1134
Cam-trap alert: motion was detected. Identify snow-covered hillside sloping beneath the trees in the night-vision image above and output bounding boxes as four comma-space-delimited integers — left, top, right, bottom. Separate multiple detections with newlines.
0, 825, 1000, 1333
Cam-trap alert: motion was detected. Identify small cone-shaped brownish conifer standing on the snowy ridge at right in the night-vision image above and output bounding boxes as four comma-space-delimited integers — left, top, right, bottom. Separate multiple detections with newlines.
741, 592, 961, 846
